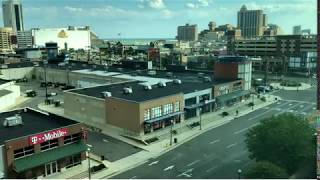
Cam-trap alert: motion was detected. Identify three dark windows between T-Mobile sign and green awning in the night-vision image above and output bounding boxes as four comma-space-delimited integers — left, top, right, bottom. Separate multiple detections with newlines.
13, 133, 81, 159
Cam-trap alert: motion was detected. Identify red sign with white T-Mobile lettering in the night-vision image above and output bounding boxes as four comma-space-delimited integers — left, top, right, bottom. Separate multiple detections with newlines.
29, 128, 68, 145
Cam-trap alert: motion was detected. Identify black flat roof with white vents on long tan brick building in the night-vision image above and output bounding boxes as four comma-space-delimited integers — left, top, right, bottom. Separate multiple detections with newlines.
68, 81, 228, 102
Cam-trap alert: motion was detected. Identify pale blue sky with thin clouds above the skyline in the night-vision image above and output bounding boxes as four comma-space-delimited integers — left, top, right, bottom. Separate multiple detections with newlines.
0, 0, 317, 39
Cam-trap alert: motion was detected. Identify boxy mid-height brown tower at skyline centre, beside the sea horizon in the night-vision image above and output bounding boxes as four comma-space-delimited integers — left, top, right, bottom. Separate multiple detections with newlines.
177, 24, 198, 41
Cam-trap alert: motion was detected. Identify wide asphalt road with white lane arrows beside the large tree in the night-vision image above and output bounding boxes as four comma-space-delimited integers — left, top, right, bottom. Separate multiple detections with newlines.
112, 89, 316, 179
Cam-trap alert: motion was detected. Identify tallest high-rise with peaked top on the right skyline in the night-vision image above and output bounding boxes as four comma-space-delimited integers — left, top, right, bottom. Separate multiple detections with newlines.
238, 5, 267, 38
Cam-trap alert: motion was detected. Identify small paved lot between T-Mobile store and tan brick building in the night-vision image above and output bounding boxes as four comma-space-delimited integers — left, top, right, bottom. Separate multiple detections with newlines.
88, 131, 142, 162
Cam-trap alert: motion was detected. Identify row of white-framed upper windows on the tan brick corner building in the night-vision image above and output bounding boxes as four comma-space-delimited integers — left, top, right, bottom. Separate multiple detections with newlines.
144, 101, 180, 120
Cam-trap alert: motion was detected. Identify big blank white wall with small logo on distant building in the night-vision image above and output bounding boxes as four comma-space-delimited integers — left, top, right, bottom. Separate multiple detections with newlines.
33, 28, 91, 49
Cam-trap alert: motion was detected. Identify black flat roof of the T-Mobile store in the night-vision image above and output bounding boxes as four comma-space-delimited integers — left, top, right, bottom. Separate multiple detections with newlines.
0, 108, 79, 145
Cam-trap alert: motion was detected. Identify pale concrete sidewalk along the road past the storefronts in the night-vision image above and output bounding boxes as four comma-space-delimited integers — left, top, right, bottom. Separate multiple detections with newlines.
39, 95, 280, 179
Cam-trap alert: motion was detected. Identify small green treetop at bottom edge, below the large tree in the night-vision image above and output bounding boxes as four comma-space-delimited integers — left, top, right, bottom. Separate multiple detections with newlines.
244, 161, 289, 179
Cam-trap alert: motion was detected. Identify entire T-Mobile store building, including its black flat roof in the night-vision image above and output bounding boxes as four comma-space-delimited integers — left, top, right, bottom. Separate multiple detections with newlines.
0, 108, 87, 179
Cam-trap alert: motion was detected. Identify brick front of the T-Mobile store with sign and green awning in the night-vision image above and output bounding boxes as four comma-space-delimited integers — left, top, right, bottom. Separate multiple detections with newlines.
0, 107, 87, 179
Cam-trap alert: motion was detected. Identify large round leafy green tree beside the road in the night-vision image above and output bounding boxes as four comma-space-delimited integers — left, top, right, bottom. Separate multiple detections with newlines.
246, 113, 316, 175
